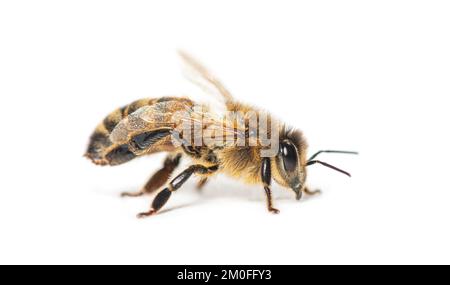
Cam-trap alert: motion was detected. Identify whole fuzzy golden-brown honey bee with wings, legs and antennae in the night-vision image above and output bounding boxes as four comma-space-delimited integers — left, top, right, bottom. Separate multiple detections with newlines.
85, 52, 356, 215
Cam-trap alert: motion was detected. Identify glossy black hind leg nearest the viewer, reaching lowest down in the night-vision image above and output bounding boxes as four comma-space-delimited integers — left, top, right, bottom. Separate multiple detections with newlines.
137, 164, 218, 218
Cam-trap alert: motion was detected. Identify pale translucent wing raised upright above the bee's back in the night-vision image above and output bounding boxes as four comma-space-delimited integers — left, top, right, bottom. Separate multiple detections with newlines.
178, 51, 234, 102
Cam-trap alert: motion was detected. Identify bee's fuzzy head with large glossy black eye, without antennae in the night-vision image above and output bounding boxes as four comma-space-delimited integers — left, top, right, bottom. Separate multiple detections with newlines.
274, 127, 307, 199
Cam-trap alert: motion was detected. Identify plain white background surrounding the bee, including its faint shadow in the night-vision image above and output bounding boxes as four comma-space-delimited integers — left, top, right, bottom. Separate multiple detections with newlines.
0, 1, 450, 264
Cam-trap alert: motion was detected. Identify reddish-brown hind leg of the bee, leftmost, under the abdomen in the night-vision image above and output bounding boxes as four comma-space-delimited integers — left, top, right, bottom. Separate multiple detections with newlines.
121, 154, 181, 197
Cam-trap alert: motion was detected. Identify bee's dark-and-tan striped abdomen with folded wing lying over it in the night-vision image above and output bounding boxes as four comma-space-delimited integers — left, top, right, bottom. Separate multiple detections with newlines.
85, 97, 194, 165
